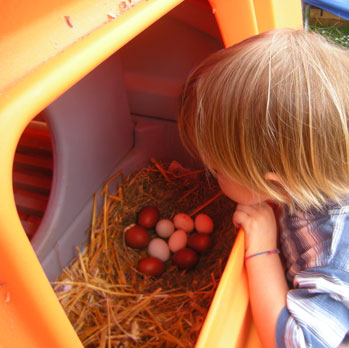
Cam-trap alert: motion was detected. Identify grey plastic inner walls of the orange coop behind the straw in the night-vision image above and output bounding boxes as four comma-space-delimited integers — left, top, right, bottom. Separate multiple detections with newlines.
32, 2, 223, 281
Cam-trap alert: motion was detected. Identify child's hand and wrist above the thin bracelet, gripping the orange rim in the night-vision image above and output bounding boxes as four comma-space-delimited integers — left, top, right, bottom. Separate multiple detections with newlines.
233, 203, 277, 256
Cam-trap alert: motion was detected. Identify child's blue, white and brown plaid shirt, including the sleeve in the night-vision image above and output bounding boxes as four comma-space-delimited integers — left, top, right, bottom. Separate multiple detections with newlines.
276, 204, 349, 348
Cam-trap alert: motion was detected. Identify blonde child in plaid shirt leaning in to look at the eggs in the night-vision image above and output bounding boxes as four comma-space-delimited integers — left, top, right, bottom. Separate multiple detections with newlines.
178, 29, 349, 348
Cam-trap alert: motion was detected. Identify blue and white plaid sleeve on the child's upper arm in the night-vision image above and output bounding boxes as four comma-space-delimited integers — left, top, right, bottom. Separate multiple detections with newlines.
276, 267, 349, 348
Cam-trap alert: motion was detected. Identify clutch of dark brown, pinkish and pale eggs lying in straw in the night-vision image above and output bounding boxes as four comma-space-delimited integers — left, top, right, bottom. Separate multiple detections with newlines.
124, 205, 214, 276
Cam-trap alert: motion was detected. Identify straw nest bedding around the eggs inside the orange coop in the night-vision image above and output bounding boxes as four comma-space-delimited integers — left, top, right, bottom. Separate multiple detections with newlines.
54, 160, 234, 348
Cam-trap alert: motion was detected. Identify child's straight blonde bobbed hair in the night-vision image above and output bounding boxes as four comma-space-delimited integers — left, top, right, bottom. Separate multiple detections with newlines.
178, 29, 349, 209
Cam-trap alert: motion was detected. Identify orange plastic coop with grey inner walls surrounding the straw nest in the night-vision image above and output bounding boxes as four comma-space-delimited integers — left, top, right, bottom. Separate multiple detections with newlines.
0, 0, 302, 348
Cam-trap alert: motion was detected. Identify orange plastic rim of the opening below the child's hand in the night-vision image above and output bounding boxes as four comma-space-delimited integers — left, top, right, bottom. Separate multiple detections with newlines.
196, 230, 260, 348
